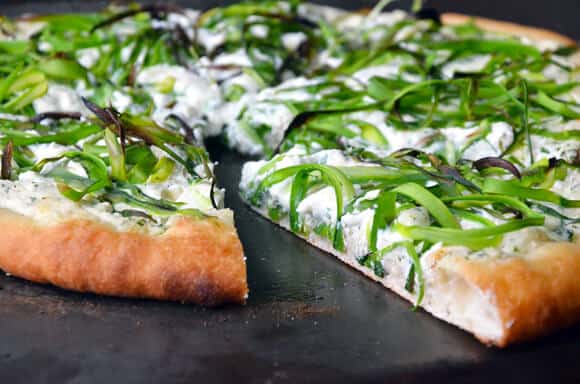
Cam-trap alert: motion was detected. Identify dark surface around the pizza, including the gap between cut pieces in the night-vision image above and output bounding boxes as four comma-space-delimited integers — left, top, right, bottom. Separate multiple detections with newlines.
0, 0, 580, 384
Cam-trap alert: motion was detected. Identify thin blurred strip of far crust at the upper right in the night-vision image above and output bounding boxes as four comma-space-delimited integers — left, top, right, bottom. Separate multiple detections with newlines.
441, 13, 576, 46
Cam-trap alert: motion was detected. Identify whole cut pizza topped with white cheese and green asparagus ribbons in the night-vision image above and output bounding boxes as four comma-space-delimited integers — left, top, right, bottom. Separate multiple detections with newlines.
0, 1, 580, 347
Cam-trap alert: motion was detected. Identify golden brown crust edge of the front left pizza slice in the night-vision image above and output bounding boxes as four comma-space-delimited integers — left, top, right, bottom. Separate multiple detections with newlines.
0, 210, 248, 305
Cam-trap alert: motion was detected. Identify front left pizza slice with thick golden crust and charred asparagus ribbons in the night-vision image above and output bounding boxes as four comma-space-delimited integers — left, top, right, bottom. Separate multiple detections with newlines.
0, 100, 248, 305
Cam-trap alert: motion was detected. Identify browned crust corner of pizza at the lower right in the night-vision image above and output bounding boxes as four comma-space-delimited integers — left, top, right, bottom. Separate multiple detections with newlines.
443, 243, 580, 347
